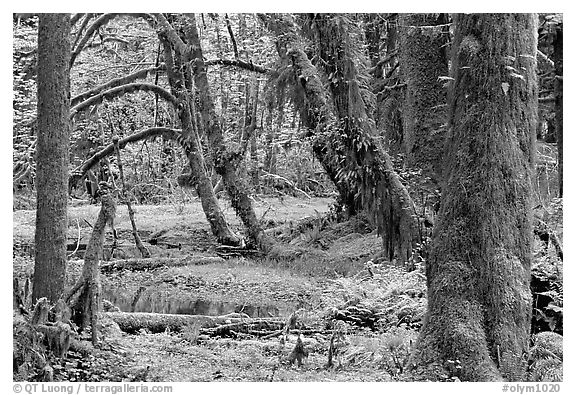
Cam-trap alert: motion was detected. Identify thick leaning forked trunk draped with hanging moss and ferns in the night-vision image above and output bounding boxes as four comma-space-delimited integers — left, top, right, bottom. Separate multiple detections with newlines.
261, 15, 420, 262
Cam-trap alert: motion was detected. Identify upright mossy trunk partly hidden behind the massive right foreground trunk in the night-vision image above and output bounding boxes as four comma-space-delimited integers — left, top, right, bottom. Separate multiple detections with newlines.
398, 14, 448, 180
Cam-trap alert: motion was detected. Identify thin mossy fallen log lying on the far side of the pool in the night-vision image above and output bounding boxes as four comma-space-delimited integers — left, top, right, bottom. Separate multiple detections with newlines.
100, 255, 225, 273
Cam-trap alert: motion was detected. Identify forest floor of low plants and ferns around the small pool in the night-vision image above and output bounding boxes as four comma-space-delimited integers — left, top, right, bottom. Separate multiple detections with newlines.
13, 198, 425, 381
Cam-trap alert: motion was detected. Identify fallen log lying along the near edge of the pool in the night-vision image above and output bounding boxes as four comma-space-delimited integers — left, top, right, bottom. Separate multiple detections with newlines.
102, 312, 284, 336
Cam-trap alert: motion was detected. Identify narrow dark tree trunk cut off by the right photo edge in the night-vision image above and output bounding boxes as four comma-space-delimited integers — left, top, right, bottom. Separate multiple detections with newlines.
554, 24, 564, 197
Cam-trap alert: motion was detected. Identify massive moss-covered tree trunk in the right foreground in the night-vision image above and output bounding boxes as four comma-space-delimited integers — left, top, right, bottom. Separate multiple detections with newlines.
413, 14, 537, 381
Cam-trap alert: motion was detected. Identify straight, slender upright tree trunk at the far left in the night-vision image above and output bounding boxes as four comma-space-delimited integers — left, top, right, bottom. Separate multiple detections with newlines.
32, 14, 70, 303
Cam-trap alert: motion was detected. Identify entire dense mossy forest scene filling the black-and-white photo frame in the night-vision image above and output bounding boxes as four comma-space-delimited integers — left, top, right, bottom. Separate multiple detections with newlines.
12, 13, 563, 382
